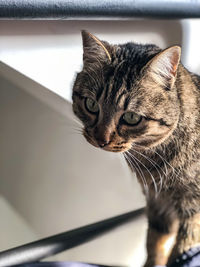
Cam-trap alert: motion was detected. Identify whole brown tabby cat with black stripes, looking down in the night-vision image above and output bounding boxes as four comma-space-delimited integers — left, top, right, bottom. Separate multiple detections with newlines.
72, 31, 200, 267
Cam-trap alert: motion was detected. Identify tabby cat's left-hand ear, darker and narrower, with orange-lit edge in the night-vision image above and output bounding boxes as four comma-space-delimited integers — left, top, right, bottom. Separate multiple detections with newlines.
81, 30, 111, 62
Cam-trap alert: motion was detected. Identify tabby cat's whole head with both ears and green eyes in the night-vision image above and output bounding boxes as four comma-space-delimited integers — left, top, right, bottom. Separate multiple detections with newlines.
73, 31, 180, 152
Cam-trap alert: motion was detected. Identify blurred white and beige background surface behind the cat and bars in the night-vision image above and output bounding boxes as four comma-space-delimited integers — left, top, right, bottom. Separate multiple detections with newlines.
0, 15, 200, 267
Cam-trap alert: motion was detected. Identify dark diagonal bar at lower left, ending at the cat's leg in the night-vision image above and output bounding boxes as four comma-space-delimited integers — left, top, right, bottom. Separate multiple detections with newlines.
0, 208, 145, 267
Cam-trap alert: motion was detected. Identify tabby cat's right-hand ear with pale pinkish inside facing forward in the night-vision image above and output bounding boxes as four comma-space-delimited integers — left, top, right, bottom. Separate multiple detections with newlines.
148, 46, 181, 89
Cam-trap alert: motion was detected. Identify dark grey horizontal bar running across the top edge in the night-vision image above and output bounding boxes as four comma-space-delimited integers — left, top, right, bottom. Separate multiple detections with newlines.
0, 0, 200, 19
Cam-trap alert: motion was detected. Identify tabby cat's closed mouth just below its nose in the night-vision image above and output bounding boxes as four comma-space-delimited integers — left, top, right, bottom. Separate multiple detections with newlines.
83, 131, 132, 152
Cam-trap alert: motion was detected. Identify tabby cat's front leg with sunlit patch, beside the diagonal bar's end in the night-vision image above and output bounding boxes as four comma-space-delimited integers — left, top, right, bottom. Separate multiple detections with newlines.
144, 198, 179, 267
